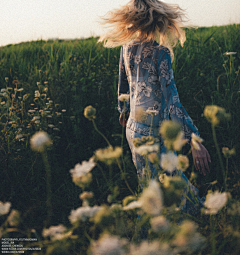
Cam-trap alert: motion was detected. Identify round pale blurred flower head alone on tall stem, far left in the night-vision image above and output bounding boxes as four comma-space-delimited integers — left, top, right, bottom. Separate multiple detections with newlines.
30, 131, 52, 152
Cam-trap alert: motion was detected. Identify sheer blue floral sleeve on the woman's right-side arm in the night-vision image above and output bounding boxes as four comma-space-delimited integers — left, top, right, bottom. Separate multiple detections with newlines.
158, 50, 199, 141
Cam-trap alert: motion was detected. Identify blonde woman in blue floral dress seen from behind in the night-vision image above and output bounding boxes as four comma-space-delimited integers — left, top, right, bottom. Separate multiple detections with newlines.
100, 0, 210, 214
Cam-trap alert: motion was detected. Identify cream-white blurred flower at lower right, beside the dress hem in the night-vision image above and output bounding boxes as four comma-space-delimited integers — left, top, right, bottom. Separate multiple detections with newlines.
204, 190, 228, 214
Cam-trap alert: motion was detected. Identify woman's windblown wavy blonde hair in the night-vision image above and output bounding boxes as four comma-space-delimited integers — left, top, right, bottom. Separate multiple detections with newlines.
99, 0, 186, 56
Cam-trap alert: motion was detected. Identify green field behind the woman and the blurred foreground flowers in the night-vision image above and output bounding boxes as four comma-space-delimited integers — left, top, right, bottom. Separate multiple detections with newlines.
0, 24, 240, 254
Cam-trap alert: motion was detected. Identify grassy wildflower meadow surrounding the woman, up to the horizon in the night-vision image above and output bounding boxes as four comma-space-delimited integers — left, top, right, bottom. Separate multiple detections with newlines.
0, 24, 240, 254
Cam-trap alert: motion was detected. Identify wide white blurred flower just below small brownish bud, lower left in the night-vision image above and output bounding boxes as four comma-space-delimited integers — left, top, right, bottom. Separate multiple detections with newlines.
68, 206, 101, 224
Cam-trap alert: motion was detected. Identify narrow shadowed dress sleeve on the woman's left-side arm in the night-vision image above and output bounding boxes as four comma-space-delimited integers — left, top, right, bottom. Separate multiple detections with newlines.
118, 47, 130, 113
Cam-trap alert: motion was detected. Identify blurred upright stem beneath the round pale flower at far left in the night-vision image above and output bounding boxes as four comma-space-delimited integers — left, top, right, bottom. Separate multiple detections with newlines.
42, 150, 52, 227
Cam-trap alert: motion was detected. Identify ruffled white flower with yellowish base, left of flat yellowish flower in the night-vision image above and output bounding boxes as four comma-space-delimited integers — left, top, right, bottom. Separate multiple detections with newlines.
69, 158, 96, 187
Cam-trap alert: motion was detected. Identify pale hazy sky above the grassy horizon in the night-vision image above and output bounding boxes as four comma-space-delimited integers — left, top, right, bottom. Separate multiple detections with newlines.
0, 0, 240, 46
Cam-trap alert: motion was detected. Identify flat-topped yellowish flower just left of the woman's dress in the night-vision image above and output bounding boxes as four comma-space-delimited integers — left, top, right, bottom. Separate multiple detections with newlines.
95, 146, 122, 165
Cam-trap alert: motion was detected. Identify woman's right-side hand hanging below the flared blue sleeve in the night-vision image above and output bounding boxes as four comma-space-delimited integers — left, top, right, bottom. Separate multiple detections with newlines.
190, 143, 211, 175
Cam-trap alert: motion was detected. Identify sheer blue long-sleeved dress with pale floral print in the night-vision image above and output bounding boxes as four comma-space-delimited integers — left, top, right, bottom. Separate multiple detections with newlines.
118, 40, 205, 214
